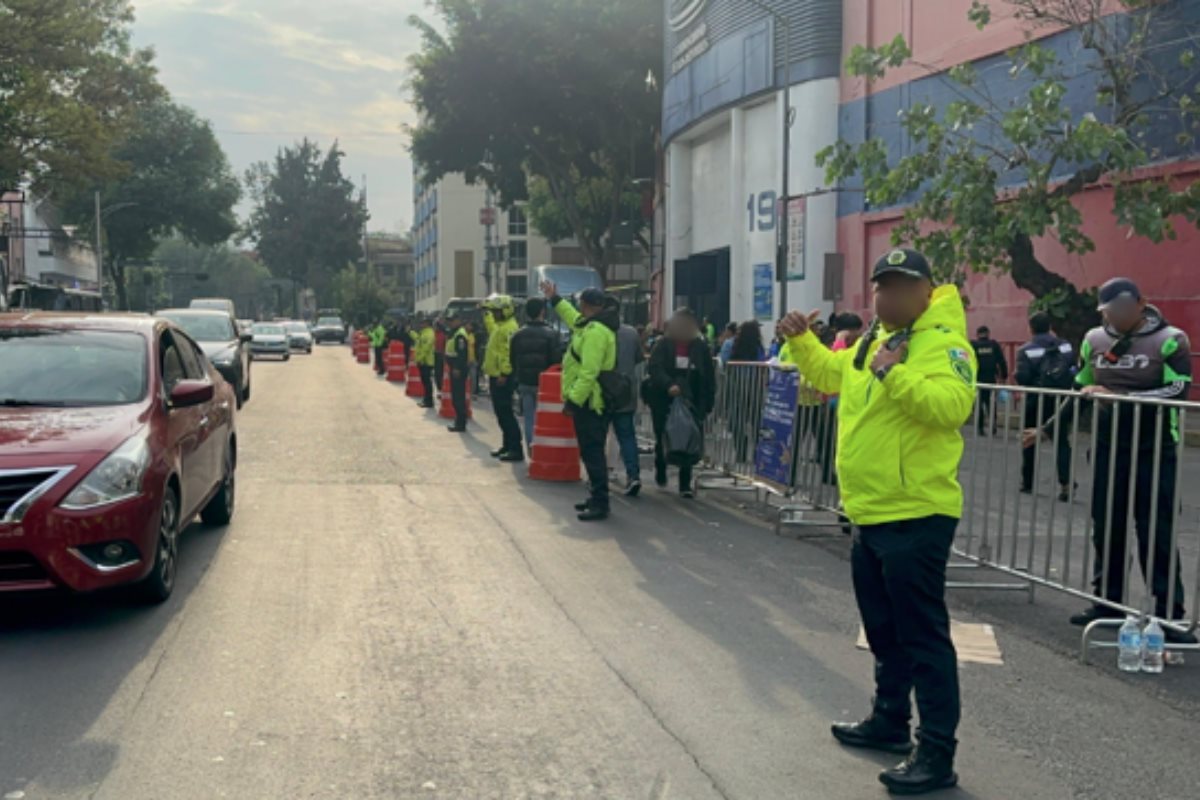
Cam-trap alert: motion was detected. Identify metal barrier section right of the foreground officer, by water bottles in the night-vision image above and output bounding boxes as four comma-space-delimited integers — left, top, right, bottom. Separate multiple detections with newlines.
947, 384, 1200, 661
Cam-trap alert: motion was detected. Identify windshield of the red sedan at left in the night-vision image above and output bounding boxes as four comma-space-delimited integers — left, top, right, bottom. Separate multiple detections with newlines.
0, 329, 148, 407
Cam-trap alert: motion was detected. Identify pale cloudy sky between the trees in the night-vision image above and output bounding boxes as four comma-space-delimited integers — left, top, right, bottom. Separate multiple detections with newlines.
133, 0, 428, 231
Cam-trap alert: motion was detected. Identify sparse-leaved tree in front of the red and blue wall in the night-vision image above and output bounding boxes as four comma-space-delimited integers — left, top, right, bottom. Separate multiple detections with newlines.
817, 0, 1200, 341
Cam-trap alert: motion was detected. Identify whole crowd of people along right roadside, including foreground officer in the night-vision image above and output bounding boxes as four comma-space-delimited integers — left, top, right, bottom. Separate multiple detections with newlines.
352, 249, 1195, 794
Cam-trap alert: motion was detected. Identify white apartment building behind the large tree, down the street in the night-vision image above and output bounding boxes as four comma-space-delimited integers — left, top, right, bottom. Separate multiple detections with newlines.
413, 170, 556, 312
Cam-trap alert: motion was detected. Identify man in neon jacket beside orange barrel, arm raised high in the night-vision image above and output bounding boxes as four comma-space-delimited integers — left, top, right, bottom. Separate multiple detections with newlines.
541, 281, 620, 522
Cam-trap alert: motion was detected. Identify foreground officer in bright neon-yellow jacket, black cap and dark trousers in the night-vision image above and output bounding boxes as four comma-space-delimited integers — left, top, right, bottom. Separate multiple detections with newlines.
780, 249, 977, 794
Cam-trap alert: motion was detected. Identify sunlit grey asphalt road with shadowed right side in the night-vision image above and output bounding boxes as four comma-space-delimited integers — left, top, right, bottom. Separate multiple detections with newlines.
0, 348, 1200, 800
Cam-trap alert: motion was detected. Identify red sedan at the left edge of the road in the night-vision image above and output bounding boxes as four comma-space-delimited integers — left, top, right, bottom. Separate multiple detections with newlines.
0, 314, 238, 602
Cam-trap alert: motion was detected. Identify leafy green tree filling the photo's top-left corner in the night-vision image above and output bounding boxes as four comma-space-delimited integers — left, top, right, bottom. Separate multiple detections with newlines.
0, 0, 162, 196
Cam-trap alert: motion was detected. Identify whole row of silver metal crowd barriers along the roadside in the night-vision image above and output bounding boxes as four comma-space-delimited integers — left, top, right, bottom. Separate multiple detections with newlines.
667, 362, 1200, 661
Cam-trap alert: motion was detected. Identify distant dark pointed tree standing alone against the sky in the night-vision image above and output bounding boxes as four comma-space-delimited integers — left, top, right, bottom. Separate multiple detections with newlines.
246, 139, 368, 313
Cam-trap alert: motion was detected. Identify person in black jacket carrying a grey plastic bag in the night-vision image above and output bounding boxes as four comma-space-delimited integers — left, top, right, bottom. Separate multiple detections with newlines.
643, 308, 716, 498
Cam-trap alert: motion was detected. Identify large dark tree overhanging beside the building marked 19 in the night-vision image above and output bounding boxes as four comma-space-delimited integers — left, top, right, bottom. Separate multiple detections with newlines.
410, 0, 662, 272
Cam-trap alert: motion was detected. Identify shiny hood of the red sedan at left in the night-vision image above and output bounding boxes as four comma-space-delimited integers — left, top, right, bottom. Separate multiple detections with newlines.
0, 404, 148, 461
